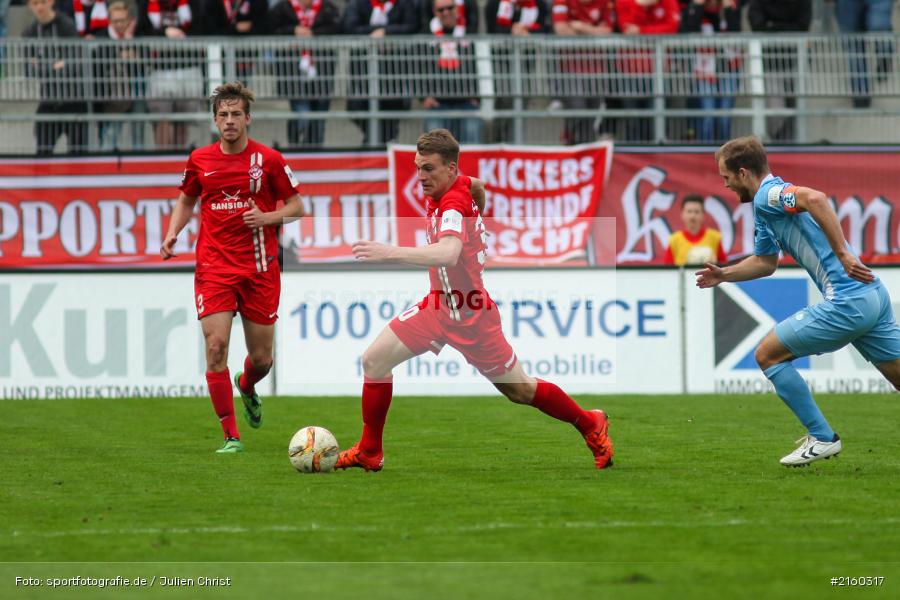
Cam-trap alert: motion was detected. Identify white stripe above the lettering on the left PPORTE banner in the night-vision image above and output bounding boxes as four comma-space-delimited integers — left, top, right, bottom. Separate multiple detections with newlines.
0, 169, 388, 190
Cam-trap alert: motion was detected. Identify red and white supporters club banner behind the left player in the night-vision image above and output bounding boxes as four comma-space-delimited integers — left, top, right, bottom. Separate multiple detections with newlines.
0, 152, 390, 269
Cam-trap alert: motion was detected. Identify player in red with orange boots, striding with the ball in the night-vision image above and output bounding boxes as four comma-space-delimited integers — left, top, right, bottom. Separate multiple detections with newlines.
335, 129, 613, 471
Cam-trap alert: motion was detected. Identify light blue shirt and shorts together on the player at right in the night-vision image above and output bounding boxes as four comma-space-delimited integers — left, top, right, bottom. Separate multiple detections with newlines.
753, 175, 900, 364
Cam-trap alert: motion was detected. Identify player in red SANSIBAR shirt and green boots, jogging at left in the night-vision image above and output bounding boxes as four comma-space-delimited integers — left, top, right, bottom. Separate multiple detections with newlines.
160, 83, 303, 453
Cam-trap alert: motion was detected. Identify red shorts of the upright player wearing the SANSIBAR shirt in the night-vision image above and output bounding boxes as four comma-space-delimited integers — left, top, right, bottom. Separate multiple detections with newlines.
194, 268, 281, 325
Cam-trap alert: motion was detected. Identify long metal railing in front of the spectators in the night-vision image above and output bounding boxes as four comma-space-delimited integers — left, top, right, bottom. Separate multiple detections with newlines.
0, 34, 900, 153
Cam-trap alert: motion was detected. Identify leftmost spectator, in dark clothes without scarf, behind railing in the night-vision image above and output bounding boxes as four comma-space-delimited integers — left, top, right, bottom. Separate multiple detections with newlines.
22, 0, 87, 156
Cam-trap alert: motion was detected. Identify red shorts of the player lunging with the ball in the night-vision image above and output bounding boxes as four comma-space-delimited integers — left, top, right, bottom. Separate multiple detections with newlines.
390, 297, 516, 377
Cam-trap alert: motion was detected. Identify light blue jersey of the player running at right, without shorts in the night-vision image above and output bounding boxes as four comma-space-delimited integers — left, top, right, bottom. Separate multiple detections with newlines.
753, 175, 878, 300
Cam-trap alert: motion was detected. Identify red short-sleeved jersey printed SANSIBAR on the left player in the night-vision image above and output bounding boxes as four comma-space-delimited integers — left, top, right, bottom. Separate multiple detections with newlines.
178, 140, 299, 273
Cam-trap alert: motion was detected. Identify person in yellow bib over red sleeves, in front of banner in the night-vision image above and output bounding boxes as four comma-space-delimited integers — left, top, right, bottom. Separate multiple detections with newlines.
663, 194, 728, 267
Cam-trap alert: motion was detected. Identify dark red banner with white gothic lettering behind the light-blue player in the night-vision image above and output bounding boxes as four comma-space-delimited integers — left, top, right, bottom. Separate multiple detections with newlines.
595, 148, 900, 265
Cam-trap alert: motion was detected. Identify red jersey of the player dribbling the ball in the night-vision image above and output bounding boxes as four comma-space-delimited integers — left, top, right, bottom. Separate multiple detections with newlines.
425, 175, 494, 324
